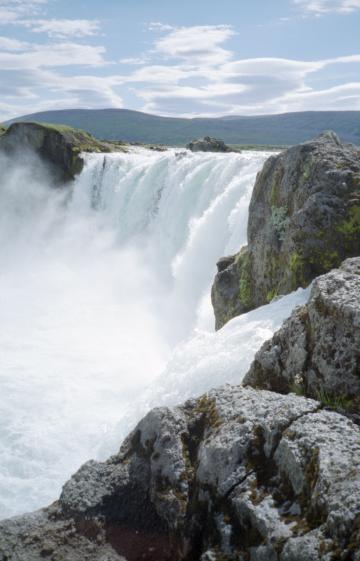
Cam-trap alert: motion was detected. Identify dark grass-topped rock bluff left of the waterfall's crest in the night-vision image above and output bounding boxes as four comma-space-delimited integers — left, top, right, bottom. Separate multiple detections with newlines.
0, 123, 123, 183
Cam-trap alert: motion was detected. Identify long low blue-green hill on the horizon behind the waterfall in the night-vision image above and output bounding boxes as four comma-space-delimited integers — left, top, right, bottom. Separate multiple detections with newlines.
7, 109, 360, 146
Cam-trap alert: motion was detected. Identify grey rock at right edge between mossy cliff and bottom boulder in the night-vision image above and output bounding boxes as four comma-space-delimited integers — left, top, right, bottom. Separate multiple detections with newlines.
244, 257, 360, 412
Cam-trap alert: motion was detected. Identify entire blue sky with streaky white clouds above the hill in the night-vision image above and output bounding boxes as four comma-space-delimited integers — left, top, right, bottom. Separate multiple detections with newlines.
0, 0, 360, 120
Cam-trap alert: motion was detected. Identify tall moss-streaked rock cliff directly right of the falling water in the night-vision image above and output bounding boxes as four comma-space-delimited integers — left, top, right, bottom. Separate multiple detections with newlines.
212, 133, 360, 329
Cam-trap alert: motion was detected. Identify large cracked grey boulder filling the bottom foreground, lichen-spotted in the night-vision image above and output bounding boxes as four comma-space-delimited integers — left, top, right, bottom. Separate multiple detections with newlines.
0, 386, 360, 561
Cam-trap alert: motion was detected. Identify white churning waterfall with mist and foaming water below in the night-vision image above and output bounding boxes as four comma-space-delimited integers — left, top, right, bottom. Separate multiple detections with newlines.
0, 149, 306, 517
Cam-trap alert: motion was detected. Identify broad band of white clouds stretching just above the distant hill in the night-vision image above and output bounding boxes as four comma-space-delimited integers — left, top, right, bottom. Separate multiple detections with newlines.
0, 18, 360, 119
